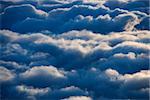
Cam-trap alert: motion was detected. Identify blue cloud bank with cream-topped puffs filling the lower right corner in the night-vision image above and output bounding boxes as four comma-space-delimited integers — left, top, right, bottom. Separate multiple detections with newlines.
65, 68, 149, 99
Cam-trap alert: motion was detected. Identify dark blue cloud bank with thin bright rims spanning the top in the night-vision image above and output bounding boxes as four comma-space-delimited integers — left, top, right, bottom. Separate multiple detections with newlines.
0, 1, 148, 34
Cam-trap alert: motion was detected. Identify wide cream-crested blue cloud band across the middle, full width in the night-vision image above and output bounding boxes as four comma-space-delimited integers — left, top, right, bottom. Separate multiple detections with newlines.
0, 30, 150, 73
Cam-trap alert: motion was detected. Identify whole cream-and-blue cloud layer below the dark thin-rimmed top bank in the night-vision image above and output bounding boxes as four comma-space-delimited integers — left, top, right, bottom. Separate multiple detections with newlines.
0, 30, 150, 99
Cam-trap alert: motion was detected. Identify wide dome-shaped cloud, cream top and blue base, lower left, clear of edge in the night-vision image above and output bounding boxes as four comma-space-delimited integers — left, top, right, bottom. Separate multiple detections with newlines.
20, 66, 65, 87
